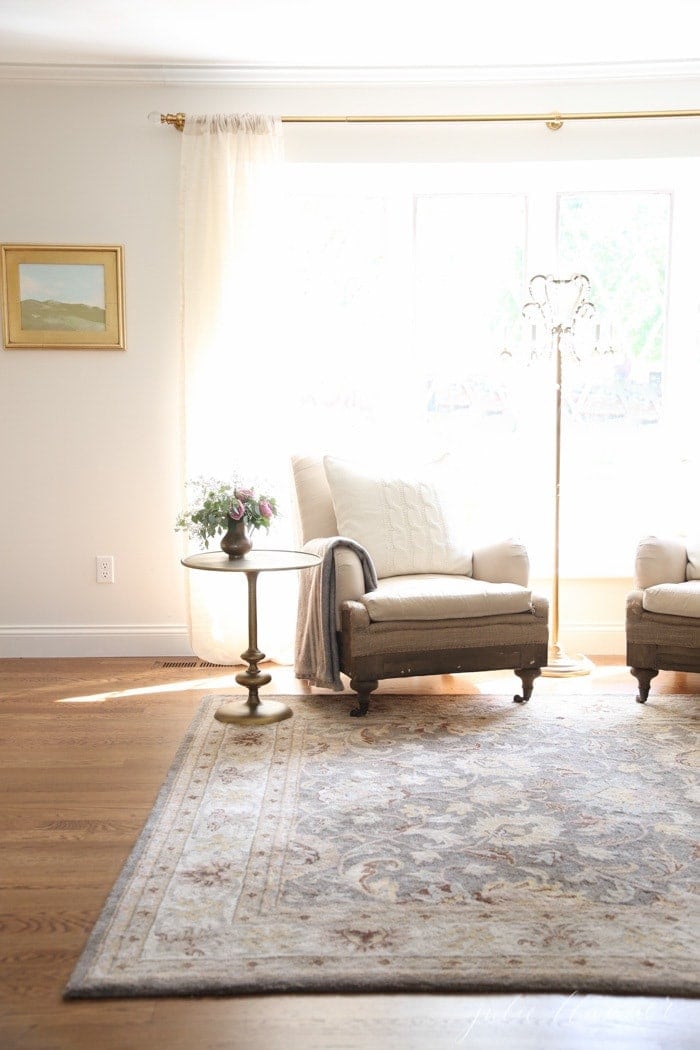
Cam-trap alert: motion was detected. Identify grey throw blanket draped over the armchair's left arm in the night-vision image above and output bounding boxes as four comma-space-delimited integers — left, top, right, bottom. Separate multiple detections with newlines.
294, 536, 377, 693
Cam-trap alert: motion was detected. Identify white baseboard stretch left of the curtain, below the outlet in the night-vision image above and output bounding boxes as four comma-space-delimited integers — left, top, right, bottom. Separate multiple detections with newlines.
0, 624, 193, 659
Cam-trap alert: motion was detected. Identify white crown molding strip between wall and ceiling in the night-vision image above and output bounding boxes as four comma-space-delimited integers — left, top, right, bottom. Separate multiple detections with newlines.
0, 59, 700, 86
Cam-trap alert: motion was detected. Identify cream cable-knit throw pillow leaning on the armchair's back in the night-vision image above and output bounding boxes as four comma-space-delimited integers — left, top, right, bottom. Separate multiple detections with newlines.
323, 456, 471, 579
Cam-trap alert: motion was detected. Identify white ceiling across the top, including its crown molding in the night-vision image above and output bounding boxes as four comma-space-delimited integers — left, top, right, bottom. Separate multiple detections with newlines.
0, 0, 700, 79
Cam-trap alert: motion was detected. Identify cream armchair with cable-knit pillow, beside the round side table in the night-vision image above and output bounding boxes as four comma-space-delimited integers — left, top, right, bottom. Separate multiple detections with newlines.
292, 456, 549, 715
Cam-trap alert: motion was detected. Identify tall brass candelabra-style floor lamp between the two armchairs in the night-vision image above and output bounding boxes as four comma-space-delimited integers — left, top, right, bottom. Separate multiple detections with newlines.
523, 273, 595, 678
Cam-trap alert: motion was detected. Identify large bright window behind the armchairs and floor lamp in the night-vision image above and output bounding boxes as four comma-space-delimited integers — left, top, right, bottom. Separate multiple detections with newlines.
284, 160, 700, 576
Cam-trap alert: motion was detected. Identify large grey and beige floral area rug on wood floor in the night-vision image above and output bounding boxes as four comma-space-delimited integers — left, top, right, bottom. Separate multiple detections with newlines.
65, 694, 700, 998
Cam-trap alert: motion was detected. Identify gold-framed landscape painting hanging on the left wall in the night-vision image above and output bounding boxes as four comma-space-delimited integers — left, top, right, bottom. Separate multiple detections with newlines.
0, 245, 125, 350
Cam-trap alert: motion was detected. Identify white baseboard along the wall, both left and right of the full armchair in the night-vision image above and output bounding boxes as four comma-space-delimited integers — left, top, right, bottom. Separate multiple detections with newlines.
0, 624, 625, 659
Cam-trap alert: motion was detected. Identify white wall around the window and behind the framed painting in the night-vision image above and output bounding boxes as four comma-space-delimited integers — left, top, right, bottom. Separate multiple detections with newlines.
0, 74, 700, 656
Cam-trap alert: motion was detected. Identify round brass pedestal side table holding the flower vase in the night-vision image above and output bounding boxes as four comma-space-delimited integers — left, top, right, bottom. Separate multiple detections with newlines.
182, 548, 321, 726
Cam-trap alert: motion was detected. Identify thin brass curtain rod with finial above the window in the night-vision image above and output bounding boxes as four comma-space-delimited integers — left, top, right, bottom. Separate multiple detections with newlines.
161, 109, 700, 131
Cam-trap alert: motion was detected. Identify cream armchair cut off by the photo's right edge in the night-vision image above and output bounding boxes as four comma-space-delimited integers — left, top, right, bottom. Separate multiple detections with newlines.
625, 536, 700, 704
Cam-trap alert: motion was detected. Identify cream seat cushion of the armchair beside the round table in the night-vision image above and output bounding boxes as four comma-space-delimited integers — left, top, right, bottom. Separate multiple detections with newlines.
360, 573, 532, 623
